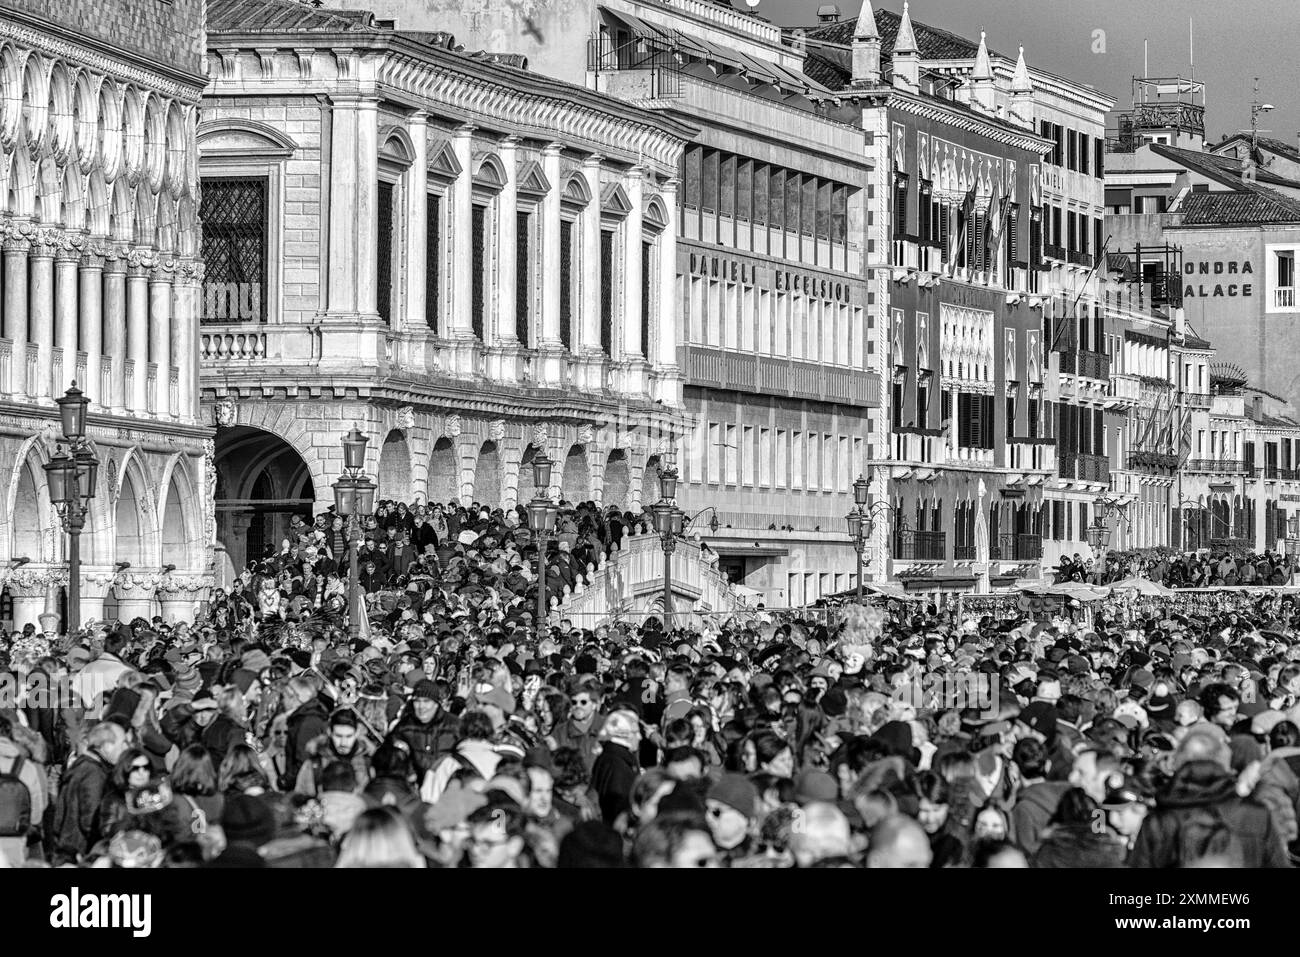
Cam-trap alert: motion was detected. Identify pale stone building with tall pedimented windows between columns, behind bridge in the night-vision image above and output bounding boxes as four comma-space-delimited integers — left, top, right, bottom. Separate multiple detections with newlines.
198, 0, 692, 582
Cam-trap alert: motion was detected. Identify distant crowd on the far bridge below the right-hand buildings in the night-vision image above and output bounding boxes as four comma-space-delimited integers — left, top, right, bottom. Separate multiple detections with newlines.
1056, 549, 1296, 588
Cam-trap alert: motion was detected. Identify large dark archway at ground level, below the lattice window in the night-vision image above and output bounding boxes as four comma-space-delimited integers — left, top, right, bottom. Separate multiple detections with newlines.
215, 425, 316, 572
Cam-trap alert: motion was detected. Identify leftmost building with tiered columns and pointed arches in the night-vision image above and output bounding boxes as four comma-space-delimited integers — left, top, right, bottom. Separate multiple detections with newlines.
0, 0, 215, 627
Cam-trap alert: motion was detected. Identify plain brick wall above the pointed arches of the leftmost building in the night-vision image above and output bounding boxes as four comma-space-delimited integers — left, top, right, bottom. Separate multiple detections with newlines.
0, 0, 207, 75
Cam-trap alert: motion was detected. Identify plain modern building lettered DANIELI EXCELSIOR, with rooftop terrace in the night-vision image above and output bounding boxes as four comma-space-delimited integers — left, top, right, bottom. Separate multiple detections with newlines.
319, 0, 885, 606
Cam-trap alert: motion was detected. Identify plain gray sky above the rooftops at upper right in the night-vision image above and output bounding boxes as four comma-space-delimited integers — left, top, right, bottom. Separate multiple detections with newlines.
759, 0, 1300, 144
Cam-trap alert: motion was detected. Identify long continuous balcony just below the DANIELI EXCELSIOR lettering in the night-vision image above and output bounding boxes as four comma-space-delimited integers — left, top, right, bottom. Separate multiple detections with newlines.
677, 346, 880, 407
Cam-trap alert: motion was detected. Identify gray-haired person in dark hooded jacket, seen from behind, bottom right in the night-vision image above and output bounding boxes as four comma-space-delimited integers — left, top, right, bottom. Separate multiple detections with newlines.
1128, 722, 1291, 867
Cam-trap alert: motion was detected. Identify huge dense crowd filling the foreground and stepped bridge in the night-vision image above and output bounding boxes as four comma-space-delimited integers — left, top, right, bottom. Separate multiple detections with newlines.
0, 506, 1300, 867
